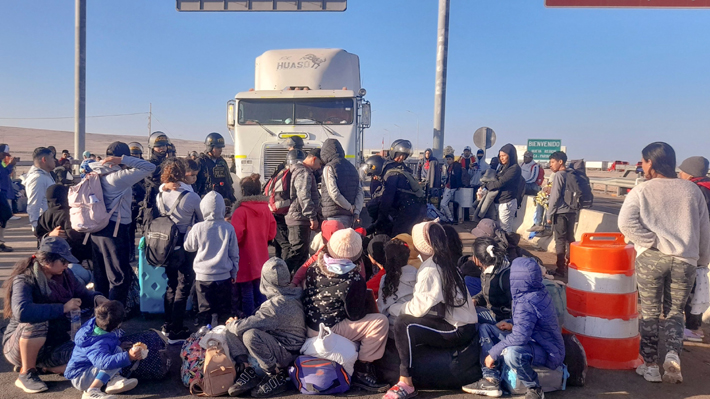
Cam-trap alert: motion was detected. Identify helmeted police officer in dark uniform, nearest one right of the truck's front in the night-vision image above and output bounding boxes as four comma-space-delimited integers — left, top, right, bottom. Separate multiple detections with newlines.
368, 139, 426, 237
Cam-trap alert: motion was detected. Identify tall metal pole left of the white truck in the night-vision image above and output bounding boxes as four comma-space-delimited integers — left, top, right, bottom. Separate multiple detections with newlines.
74, 0, 86, 164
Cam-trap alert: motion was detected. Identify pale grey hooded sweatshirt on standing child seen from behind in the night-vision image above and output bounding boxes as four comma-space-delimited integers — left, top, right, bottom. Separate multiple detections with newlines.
185, 191, 239, 281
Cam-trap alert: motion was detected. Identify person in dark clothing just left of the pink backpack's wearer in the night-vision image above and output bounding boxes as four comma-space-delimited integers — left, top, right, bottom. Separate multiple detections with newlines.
35, 184, 91, 263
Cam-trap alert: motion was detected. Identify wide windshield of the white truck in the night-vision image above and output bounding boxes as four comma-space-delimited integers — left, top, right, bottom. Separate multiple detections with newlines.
239, 98, 354, 125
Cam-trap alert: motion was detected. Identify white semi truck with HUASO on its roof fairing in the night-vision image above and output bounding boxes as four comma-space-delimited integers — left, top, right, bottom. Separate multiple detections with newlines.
227, 49, 371, 179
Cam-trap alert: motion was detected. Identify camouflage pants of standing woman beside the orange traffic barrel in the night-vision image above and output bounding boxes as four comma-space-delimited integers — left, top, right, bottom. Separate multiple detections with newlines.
636, 249, 696, 363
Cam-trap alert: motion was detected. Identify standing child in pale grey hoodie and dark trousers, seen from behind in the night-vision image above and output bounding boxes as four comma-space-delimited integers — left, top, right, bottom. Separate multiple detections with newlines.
184, 191, 239, 325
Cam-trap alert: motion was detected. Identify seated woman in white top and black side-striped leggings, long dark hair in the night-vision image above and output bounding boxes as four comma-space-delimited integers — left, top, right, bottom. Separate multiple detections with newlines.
384, 222, 477, 399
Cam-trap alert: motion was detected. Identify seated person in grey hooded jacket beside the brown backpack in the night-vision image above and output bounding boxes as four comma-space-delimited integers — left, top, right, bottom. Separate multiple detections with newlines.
227, 258, 306, 398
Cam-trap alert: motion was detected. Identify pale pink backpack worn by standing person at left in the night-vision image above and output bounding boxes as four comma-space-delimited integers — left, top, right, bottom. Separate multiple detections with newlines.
68, 172, 123, 238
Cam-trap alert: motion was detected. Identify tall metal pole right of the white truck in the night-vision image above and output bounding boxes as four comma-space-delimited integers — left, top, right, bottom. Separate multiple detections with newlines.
432, 0, 450, 159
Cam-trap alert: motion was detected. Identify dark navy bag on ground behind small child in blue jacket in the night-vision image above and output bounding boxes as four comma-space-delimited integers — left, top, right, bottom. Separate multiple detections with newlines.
121, 331, 172, 381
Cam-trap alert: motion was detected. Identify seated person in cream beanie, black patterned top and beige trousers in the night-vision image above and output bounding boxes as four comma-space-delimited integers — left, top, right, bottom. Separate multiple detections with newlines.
303, 228, 389, 392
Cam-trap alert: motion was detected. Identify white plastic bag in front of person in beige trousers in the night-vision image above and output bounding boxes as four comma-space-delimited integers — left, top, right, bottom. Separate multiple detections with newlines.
301, 323, 357, 375
